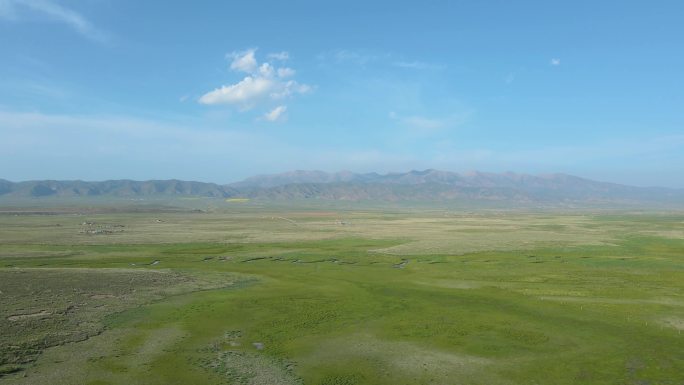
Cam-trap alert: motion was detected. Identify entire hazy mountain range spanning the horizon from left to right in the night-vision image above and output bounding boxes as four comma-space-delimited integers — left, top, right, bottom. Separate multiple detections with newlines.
0, 169, 684, 205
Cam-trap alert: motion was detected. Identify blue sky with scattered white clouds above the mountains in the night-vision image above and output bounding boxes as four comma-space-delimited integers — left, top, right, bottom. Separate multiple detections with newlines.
0, 0, 684, 188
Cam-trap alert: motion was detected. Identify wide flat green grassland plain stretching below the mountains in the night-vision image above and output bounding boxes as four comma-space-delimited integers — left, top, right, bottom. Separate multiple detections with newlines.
0, 200, 684, 385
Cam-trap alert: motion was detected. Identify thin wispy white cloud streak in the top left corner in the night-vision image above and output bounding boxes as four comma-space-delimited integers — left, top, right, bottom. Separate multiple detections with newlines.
0, 0, 107, 41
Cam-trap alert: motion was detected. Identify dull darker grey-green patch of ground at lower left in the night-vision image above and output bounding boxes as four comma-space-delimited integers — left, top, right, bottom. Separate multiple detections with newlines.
0, 268, 244, 372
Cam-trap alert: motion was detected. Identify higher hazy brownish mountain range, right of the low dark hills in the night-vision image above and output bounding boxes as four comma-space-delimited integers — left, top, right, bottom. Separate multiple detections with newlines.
228, 169, 684, 203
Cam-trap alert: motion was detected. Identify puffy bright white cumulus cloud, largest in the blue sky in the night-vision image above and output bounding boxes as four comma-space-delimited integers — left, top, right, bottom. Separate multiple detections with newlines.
199, 48, 312, 117
